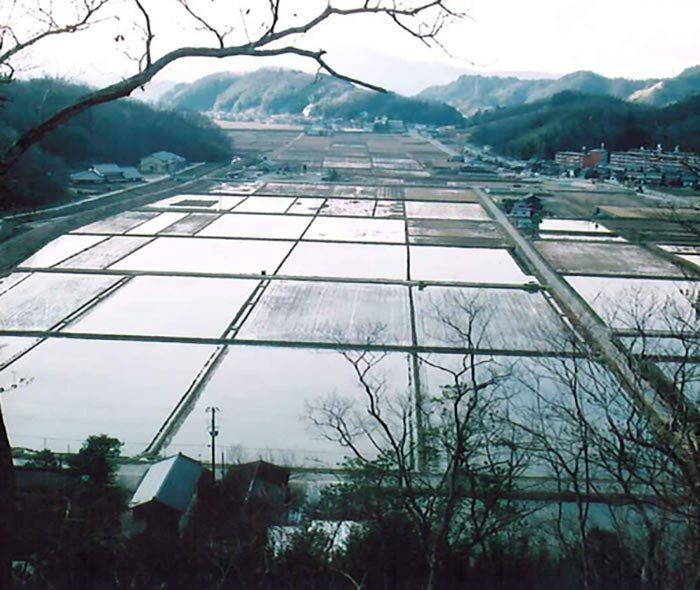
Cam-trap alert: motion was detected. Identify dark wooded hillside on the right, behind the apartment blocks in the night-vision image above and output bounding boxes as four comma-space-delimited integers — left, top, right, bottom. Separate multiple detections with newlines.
467, 92, 700, 159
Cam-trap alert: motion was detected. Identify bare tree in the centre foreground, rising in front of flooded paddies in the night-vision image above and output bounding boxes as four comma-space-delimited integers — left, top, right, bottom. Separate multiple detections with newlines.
309, 297, 527, 588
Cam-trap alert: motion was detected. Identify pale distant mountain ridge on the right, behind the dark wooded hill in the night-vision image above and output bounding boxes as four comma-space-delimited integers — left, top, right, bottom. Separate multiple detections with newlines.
416, 66, 700, 115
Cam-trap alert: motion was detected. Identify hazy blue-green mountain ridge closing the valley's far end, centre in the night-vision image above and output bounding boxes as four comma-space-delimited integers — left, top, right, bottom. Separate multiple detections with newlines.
159, 68, 463, 125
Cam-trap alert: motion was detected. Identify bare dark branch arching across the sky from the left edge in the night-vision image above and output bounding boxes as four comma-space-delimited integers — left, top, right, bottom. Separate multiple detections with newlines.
0, 0, 462, 177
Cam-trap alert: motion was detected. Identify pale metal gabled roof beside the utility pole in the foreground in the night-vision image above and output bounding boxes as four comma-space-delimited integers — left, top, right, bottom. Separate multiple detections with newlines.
129, 454, 204, 512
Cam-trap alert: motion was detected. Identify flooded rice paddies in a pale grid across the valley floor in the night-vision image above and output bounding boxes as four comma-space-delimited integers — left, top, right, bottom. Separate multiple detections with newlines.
0, 173, 697, 466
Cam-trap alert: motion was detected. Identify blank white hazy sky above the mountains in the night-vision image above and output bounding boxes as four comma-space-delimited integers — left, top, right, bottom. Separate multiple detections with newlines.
6, 0, 700, 91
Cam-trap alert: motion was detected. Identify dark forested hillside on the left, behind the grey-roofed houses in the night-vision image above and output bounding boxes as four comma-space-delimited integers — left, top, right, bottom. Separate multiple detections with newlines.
0, 79, 230, 210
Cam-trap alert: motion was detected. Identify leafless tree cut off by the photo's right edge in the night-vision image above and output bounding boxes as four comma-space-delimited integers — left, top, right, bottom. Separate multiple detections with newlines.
604, 290, 700, 587
